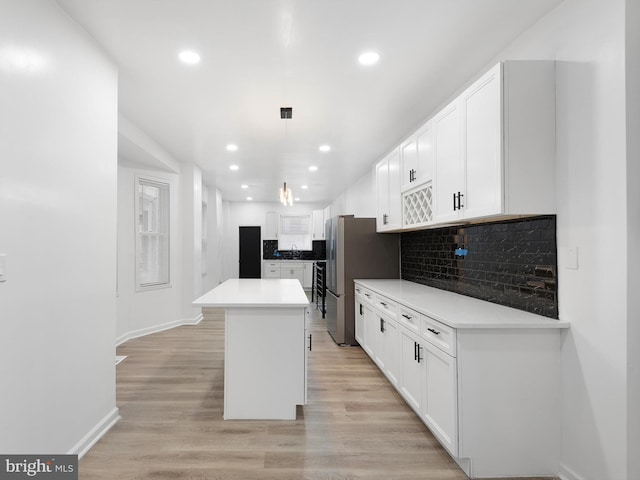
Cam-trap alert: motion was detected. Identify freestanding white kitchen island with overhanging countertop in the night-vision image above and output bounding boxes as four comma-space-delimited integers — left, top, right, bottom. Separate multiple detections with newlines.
193, 279, 309, 420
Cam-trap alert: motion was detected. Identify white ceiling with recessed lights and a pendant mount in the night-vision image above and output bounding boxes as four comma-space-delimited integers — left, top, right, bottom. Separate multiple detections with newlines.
58, 0, 561, 204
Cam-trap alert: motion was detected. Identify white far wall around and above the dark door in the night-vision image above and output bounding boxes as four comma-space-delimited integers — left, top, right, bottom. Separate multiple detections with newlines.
223, 202, 326, 280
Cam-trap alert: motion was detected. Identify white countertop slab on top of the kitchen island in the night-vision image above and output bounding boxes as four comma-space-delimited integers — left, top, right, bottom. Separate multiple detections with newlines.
192, 278, 309, 307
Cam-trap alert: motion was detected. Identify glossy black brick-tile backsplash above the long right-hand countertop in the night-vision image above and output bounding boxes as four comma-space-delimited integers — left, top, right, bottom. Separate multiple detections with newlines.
401, 215, 558, 318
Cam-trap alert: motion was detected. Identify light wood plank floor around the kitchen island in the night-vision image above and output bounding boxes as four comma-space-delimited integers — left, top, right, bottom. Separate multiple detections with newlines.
79, 302, 552, 480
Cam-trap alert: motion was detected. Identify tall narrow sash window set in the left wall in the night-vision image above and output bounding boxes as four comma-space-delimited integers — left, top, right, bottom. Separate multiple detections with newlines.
136, 177, 170, 290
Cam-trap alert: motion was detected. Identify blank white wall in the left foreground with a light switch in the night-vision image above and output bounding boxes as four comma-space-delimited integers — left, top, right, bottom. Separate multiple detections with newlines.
0, 0, 118, 454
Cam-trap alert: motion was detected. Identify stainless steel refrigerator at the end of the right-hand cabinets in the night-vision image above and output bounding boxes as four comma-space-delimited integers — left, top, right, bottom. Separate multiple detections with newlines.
325, 215, 400, 345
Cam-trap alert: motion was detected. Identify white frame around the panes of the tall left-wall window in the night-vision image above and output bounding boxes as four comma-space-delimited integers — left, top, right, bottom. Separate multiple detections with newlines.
134, 174, 171, 292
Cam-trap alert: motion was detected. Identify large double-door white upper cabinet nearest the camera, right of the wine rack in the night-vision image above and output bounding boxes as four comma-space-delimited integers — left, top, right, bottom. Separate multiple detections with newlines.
433, 61, 555, 223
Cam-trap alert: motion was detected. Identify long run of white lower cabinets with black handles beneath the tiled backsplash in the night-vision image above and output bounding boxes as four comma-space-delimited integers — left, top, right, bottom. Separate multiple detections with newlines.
355, 280, 562, 478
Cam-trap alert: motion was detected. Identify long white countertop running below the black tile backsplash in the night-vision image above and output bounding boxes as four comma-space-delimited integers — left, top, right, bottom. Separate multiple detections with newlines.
355, 280, 569, 328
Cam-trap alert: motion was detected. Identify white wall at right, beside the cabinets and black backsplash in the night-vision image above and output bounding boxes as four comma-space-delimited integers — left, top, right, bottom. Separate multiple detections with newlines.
501, 0, 624, 480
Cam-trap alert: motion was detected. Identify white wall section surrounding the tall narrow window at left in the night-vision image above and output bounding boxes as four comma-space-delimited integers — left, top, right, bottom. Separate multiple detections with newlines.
116, 163, 182, 344
